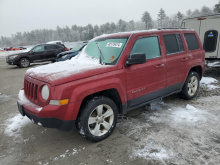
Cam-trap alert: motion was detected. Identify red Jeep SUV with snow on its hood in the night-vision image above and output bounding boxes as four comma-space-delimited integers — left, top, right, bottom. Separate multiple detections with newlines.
18, 29, 205, 141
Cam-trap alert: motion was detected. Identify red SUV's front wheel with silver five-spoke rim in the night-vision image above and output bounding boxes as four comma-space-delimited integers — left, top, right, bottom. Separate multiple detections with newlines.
76, 96, 118, 142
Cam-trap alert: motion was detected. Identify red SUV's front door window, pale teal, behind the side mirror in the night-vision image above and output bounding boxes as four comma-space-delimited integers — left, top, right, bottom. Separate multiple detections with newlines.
130, 36, 160, 59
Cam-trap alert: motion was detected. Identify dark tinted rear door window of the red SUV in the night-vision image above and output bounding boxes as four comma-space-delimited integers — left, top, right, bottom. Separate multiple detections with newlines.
163, 34, 184, 55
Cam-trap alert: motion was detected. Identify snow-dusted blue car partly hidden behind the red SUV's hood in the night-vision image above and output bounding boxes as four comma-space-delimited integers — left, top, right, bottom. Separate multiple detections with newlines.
57, 42, 87, 61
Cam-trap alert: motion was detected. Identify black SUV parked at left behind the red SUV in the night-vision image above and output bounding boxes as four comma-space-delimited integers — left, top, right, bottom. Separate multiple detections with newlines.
6, 44, 65, 68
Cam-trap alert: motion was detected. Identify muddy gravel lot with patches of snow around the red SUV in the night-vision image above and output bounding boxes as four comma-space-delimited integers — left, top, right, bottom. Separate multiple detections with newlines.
0, 54, 220, 165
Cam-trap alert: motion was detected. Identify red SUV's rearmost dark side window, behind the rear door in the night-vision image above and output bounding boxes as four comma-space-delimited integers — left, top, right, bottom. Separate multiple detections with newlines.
184, 33, 199, 50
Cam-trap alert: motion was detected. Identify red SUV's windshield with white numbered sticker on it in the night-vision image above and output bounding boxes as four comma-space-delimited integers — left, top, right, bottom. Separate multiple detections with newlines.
85, 38, 128, 65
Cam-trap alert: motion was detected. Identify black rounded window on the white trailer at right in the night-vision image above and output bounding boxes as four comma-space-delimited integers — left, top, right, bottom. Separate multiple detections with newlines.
203, 30, 218, 52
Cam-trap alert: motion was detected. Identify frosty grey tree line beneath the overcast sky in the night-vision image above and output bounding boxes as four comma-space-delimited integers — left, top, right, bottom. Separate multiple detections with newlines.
0, 1, 220, 47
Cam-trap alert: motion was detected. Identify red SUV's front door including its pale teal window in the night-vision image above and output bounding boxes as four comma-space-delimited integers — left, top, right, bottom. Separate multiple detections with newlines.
125, 35, 166, 107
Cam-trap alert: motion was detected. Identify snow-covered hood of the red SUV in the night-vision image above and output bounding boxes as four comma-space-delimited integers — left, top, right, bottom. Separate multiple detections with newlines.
26, 53, 121, 86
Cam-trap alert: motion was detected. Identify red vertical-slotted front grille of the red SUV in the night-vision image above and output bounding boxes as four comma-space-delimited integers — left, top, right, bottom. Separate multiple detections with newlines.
24, 80, 38, 103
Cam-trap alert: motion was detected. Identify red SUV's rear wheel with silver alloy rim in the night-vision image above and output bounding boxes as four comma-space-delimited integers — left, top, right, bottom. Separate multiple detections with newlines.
180, 72, 200, 100
